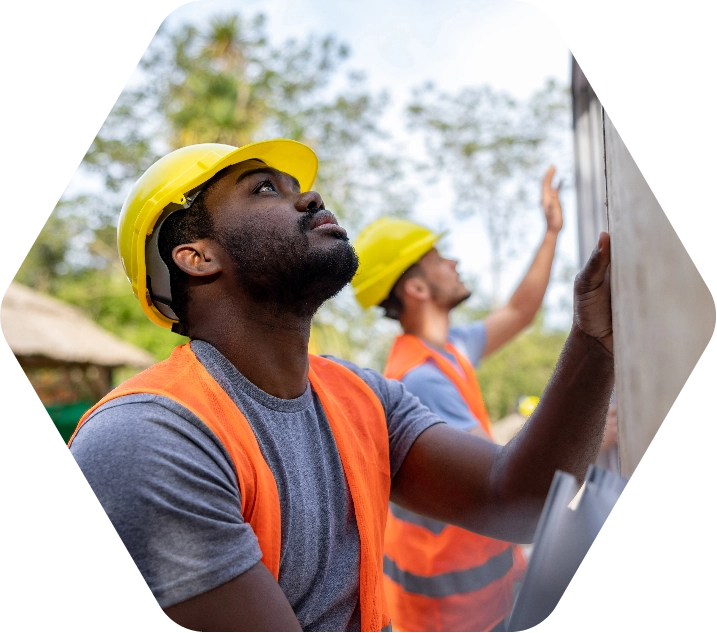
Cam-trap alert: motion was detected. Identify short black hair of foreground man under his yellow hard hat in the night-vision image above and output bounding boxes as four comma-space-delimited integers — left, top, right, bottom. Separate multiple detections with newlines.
157, 184, 214, 336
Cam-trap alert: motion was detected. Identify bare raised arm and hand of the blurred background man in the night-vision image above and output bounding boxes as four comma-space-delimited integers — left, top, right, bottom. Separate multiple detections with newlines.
483, 166, 563, 357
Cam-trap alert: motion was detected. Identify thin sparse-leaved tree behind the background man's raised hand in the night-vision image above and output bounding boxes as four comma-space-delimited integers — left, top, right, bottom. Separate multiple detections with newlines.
407, 81, 569, 306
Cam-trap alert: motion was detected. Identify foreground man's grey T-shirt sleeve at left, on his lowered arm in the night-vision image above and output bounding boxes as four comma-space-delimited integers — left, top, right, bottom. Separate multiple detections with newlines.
70, 394, 261, 608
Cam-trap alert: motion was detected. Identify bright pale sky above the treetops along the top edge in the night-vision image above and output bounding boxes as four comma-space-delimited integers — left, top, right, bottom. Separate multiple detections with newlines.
165, 0, 570, 101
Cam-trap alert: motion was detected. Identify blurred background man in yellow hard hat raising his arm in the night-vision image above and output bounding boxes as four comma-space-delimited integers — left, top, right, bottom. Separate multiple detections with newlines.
352, 167, 563, 631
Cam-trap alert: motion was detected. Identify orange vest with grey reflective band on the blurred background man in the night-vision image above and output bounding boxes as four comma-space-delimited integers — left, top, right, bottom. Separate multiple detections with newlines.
384, 334, 525, 631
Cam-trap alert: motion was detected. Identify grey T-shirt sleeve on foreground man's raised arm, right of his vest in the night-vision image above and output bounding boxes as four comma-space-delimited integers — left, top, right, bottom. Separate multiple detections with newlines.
326, 356, 443, 477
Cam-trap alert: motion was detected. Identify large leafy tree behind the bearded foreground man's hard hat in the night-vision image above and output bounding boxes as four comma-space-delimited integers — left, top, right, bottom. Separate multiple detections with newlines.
16, 15, 412, 364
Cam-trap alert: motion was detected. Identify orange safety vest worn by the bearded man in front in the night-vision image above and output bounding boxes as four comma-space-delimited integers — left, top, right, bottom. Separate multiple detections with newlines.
68, 344, 391, 631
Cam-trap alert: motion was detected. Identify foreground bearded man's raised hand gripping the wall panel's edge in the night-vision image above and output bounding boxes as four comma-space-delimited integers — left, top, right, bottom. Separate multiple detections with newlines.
573, 233, 613, 355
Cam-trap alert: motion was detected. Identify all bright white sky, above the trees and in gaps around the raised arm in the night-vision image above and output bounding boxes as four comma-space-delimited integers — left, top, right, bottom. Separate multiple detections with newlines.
75, 0, 577, 327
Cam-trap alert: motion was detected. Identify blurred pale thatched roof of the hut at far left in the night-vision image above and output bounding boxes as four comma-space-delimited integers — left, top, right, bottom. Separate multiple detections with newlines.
0, 281, 154, 368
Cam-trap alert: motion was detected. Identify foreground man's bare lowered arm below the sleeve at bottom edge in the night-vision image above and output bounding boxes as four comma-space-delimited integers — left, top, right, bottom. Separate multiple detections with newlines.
164, 563, 301, 631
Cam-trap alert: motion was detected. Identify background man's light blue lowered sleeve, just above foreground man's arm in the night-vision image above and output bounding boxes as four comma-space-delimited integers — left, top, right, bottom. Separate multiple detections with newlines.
401, 359, 488, 440
